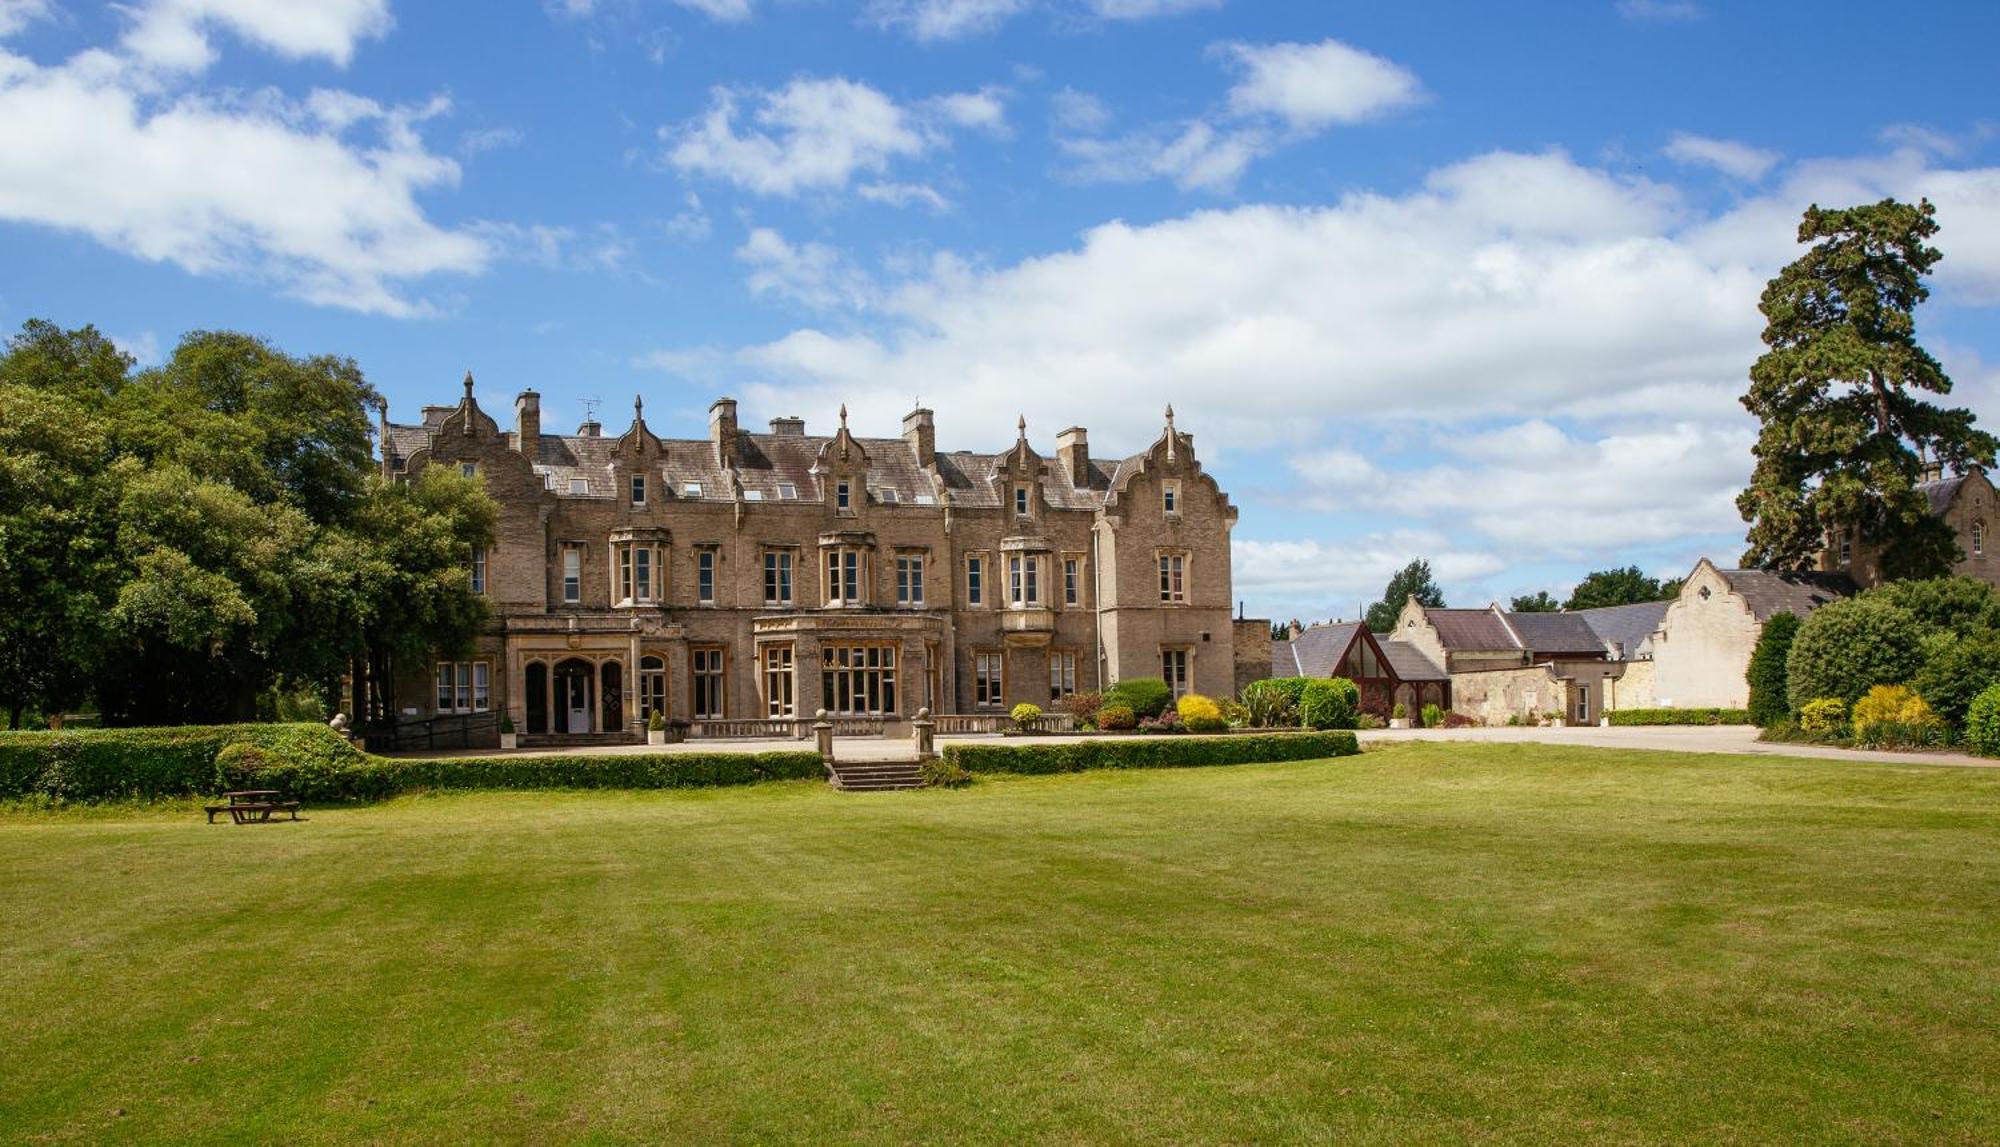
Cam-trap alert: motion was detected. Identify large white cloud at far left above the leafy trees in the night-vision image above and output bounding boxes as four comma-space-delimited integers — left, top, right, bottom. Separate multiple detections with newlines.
0, 32, 490, 316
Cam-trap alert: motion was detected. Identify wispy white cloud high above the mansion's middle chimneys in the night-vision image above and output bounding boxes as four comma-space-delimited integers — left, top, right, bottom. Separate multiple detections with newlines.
662, 78, 936, 196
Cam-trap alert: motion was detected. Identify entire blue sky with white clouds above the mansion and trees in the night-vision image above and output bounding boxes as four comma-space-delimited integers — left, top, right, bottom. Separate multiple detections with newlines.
0, 0, 2000, 617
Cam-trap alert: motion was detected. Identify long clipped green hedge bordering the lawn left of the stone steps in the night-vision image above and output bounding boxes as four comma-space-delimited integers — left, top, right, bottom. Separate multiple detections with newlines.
0, 725, 826, 801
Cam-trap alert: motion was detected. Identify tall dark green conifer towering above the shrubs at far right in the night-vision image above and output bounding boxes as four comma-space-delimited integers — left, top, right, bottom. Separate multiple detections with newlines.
1736, 200, 1994, 577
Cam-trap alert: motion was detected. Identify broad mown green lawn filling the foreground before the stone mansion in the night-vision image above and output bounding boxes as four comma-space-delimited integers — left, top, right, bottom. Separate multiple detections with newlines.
0, 743, 2000, 1143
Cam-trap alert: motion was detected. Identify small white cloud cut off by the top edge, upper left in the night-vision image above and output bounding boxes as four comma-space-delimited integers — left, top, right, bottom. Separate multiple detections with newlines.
124, 0, 390, 72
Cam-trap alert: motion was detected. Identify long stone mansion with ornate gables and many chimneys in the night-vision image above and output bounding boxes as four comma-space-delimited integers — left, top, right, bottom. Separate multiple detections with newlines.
382, 376, 1238, 735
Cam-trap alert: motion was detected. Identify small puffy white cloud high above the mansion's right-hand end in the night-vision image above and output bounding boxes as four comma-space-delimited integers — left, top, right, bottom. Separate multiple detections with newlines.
1218, 40, 1424, 132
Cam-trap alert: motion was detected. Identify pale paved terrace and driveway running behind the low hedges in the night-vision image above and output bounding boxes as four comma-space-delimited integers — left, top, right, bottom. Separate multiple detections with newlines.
378, 725, 2000, 769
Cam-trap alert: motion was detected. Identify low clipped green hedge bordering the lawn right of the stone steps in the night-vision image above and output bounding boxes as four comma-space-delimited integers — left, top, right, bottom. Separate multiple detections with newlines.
944, 731, 1362, 773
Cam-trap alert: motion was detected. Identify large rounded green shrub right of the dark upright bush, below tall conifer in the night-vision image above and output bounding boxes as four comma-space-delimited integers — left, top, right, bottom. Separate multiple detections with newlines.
1784, 593, 1924, 711
